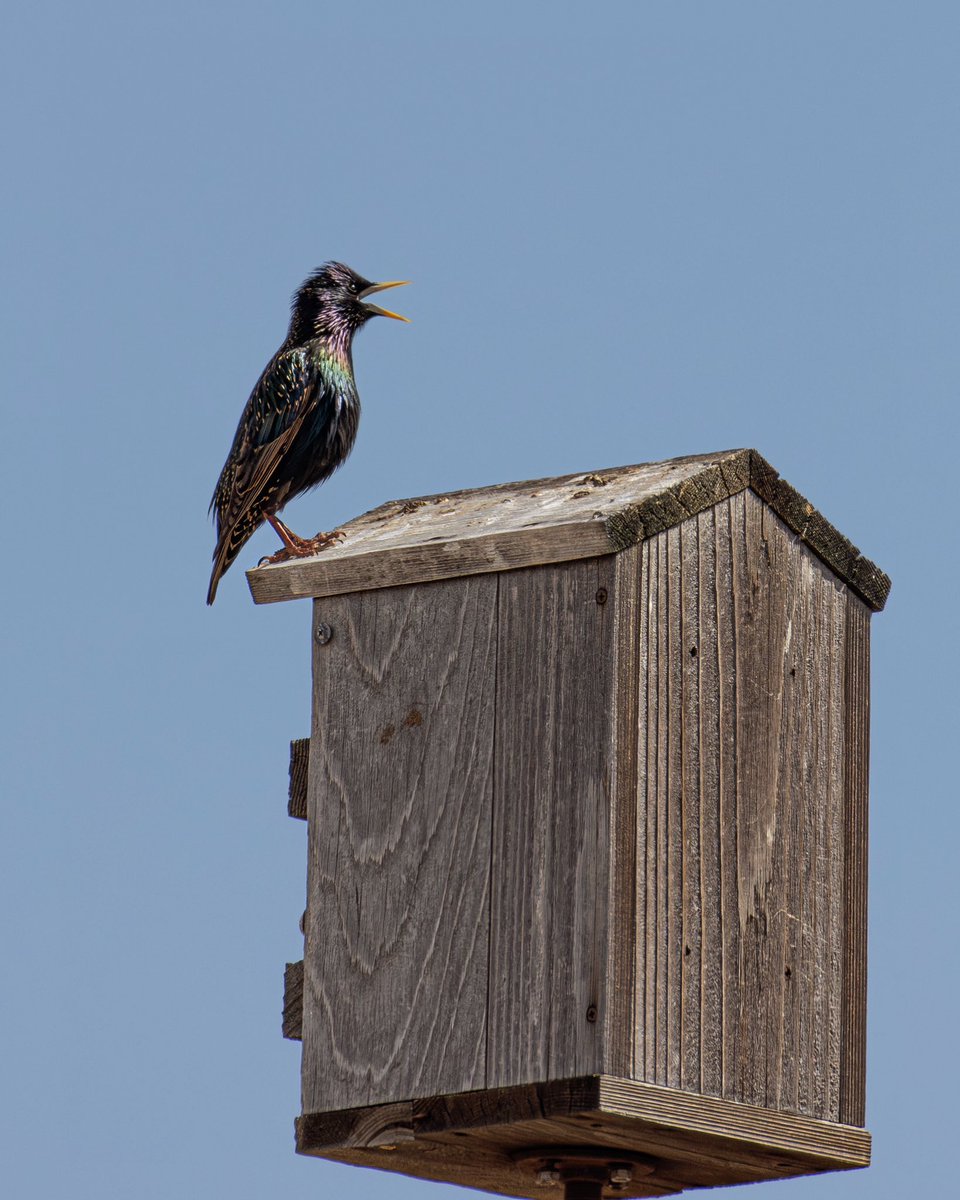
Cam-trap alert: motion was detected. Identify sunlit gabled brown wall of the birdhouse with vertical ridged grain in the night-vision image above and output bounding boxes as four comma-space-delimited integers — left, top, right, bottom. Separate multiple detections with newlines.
634, 491, 862, 1121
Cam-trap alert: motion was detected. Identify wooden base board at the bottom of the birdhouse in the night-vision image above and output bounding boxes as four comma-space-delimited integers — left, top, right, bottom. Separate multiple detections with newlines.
296, 1075, 870, 1200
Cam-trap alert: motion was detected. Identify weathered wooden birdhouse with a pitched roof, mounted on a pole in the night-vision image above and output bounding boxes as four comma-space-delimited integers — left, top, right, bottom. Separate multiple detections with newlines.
248, 450, 889, 1200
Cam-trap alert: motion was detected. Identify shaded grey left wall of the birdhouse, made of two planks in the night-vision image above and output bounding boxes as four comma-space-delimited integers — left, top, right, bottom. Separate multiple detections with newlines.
302, 556, 632, 1111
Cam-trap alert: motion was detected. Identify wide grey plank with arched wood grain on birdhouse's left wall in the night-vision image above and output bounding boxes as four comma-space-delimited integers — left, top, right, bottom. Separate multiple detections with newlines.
302, 576, 498, 1112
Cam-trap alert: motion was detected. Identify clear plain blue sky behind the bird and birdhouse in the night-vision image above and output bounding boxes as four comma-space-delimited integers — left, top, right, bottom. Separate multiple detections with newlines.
0, 0, 960, 1200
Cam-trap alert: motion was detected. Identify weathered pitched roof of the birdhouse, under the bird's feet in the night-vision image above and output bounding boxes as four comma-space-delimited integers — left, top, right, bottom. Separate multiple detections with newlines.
247, 450, 890, 611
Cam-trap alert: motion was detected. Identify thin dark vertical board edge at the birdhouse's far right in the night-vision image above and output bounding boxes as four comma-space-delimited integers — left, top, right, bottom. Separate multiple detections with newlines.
839, 598, 870, 1126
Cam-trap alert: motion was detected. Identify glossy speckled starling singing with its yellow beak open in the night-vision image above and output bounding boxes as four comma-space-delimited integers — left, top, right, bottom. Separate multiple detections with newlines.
206, 263, 409, 605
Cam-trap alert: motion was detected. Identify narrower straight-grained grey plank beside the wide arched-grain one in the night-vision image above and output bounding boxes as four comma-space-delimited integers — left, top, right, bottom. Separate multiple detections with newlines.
487, 556, 616, 1087
